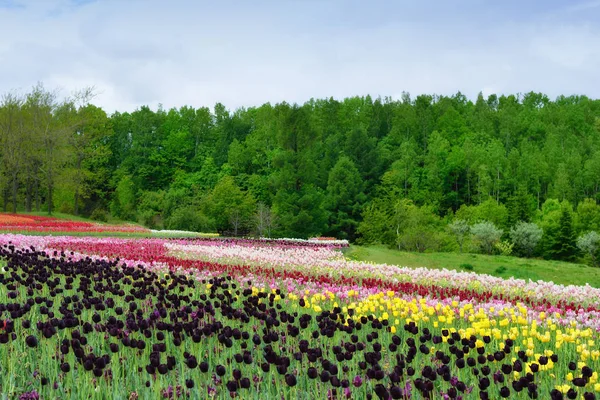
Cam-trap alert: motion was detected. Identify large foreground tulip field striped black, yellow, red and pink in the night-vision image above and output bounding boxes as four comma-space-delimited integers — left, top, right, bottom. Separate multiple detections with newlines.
0, 234, 600, 400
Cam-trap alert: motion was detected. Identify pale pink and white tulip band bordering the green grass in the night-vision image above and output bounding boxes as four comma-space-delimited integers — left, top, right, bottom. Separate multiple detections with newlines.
165, 242, 600, 311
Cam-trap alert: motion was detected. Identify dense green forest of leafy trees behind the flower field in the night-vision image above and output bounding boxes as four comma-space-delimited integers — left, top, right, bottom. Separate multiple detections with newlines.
0, 84, 600, 263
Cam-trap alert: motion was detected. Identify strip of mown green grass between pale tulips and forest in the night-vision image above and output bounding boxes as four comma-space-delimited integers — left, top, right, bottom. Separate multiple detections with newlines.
345, 246, 600, 287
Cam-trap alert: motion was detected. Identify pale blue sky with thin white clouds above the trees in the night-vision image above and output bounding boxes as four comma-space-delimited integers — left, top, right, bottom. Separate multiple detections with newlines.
0, 0, 600, 113
